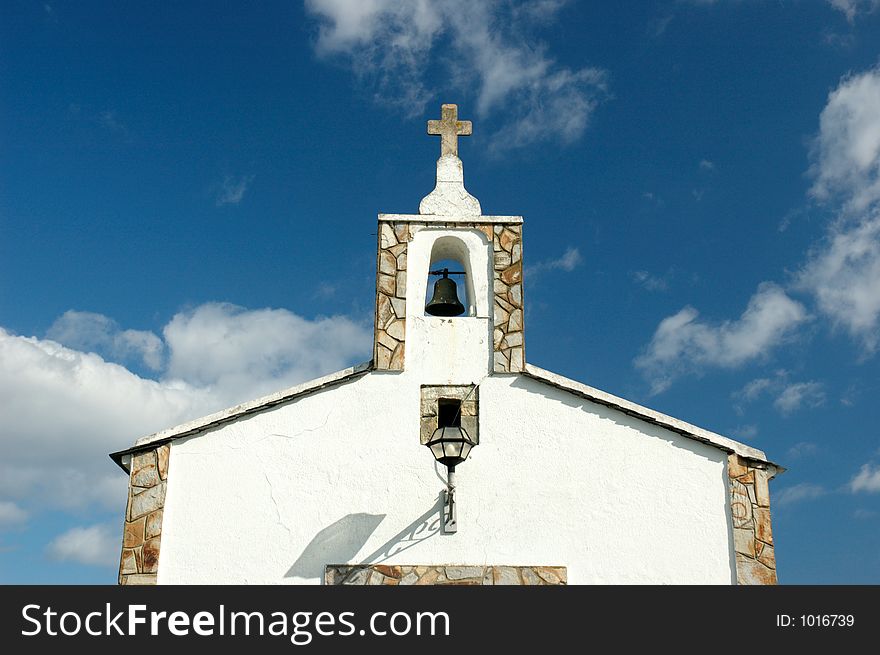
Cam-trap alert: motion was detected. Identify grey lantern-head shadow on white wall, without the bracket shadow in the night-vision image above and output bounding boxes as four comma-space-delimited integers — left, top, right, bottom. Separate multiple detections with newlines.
284, 513, 385, 578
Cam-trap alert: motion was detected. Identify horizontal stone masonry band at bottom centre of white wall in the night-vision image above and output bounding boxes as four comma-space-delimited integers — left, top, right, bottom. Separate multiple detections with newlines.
324, 564, 568, 586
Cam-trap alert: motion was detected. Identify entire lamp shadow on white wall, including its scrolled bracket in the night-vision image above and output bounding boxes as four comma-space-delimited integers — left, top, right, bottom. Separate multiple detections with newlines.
284, 493, 443, 579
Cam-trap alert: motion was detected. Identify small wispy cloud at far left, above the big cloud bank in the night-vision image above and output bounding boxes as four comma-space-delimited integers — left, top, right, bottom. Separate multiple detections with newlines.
46, 310, 165, 371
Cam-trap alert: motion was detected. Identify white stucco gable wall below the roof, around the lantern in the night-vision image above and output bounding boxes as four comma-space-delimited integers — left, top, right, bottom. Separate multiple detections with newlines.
159, 372, 734, 584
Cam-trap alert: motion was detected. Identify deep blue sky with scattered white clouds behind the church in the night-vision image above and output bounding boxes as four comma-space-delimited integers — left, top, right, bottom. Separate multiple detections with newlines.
0, 0, 880, 584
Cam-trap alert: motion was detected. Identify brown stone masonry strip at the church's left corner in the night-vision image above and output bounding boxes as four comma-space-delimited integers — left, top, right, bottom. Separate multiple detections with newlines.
119, 444, 171, 585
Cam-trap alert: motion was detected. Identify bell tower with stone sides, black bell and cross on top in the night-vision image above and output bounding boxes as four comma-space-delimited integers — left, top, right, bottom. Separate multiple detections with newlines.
373, 105, 525, 385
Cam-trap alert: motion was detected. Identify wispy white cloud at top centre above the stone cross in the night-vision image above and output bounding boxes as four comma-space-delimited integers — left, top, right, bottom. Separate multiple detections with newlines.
306, 0, 606, 149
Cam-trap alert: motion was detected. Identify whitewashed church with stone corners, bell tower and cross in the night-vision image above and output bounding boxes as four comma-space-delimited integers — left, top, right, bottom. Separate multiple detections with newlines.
111, 105, 783, 585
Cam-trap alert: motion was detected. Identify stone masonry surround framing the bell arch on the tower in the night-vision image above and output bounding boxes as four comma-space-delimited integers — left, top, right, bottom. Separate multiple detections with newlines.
373, 221, 525, 373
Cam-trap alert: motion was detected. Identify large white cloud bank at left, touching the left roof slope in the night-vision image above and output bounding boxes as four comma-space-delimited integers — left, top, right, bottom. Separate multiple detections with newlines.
0, 304, 370, 511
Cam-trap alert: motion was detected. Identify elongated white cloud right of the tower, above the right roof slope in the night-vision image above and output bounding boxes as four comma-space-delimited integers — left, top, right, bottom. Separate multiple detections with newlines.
635, 282, 808, 394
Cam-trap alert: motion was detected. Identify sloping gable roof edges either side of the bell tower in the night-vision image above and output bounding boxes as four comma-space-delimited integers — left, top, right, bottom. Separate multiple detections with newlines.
110, 361, 785, 475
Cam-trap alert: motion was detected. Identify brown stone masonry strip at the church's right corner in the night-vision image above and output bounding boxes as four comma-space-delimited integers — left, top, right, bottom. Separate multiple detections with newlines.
727, 453, 777, 585
